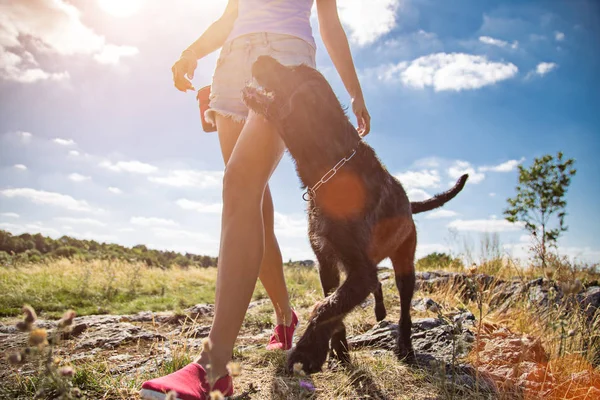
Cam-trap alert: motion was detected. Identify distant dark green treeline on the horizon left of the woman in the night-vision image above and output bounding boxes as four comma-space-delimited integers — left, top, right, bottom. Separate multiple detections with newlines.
0, 230, 217, 268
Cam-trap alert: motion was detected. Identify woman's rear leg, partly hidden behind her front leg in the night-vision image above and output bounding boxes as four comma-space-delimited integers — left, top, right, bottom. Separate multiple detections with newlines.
217, 116, 292, 325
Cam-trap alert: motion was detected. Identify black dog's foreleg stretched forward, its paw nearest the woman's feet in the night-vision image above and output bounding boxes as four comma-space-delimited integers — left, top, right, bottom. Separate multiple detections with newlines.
287, 252, 377, 373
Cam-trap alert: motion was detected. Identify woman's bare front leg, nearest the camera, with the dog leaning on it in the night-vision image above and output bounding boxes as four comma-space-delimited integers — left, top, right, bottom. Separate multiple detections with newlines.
198, 112, 285, 377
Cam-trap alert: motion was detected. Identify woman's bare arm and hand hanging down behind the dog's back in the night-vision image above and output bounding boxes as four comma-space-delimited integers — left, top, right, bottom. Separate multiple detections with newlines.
317, 0, 371, 136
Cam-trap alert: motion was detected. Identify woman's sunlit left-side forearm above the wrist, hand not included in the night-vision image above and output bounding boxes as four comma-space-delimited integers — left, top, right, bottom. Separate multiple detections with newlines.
184, 0, 237, 60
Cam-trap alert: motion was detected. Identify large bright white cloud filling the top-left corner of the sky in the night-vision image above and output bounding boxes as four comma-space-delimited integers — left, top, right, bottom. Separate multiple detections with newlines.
0, 0, 137, 83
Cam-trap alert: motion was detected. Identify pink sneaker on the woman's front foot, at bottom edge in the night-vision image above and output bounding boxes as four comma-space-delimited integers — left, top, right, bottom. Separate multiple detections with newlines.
140, 363, 233, 400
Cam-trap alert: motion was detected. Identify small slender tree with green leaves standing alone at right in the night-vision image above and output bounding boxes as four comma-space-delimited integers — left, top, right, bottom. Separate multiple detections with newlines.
504, 152, 577, 268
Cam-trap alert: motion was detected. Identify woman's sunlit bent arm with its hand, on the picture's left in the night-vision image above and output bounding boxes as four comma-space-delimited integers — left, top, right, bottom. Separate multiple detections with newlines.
171, 0, 238, 92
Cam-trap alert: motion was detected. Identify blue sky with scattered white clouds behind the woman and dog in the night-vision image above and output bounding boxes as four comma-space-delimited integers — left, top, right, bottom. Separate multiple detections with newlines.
0, 0, 600, 262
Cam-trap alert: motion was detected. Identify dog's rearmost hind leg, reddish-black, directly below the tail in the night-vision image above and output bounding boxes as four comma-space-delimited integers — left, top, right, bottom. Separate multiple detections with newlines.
391, 228, 417, 361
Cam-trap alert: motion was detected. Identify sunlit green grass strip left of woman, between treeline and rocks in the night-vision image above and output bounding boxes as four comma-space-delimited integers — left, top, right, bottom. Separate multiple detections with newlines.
0, 260, 226, 317
